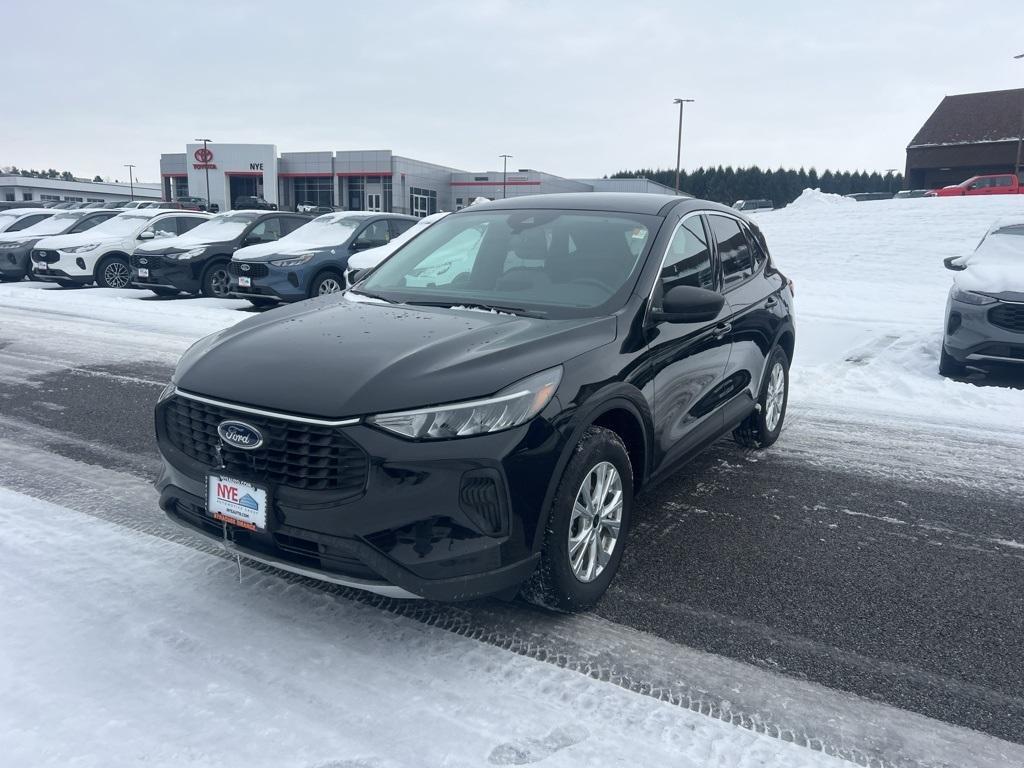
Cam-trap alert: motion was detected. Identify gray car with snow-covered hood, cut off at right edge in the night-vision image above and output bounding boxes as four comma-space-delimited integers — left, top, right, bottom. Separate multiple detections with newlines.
939, 220, 1024, 376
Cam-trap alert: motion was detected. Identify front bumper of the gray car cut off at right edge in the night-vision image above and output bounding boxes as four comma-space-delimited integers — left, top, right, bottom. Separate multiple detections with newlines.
942, 298, 1024, 368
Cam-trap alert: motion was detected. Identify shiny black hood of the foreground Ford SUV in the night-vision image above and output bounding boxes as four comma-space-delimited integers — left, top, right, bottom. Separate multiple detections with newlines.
174, 294, 615, 419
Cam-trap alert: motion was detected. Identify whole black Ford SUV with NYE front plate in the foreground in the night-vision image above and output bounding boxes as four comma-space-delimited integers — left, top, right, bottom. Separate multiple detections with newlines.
156, 193, 795, 610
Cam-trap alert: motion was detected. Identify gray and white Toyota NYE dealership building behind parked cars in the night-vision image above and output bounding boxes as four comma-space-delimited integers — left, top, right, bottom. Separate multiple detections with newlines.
160, 143, 675, 217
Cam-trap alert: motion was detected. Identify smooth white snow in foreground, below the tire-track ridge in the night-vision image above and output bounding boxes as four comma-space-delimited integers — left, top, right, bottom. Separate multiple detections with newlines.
0, 490, 847, 768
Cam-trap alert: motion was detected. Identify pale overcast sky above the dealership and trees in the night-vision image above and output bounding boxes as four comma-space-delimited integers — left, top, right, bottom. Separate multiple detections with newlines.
0, 0, 1024, 181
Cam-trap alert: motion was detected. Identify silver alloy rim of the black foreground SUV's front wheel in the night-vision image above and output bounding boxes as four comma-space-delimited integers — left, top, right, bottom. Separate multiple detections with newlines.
568, 462, 623, 583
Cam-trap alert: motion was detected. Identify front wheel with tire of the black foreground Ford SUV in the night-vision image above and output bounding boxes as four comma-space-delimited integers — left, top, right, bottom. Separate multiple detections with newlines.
522, 427, 633, 612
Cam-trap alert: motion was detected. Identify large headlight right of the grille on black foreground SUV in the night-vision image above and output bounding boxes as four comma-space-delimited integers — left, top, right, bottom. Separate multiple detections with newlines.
368, 366, 562, 440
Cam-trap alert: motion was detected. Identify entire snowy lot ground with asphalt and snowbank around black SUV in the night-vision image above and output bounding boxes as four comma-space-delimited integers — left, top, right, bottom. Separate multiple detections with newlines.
0, 191, 1024, 768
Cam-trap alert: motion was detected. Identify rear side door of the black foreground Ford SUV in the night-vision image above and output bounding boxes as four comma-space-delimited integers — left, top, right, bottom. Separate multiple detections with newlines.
708, 213, 783, 426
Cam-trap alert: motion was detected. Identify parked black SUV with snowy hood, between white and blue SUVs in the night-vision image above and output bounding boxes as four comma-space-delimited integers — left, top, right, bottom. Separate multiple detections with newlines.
131, 211, 310, 298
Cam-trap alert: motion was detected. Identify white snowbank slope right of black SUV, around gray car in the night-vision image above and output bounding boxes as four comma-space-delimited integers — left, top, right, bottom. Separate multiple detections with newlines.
755, 193, 1024, 430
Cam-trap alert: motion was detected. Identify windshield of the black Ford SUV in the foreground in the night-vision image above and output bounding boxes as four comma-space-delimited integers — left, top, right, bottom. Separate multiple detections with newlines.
357, 210, 659, 317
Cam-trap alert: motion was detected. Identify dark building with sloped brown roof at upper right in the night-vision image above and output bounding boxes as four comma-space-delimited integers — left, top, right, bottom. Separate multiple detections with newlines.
904, 88, 1024, 189
